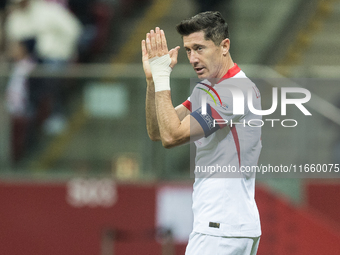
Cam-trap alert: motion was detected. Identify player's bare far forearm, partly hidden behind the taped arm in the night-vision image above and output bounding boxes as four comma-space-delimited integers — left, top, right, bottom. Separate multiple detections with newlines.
145, 79, 161, 141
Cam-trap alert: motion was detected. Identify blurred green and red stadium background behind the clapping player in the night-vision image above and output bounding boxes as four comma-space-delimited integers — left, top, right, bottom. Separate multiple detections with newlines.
0, 0, 340, 255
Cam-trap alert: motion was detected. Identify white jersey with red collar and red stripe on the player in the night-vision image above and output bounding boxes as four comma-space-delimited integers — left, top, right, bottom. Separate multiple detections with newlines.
184, 64, 262, 237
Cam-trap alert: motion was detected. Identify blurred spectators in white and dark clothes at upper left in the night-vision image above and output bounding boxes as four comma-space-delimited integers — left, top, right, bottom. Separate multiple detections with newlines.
0, 0, 113, 162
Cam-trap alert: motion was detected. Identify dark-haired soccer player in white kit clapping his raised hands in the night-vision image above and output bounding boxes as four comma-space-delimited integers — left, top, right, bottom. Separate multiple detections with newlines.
142, 12, 262, 255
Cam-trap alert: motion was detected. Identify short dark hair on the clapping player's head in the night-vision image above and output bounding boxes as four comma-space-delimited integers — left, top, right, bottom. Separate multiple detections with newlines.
176, 11, 229, 45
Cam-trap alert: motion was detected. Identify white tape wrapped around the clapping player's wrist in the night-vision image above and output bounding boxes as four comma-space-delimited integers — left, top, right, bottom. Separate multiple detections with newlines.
149, 54, 172, 92
